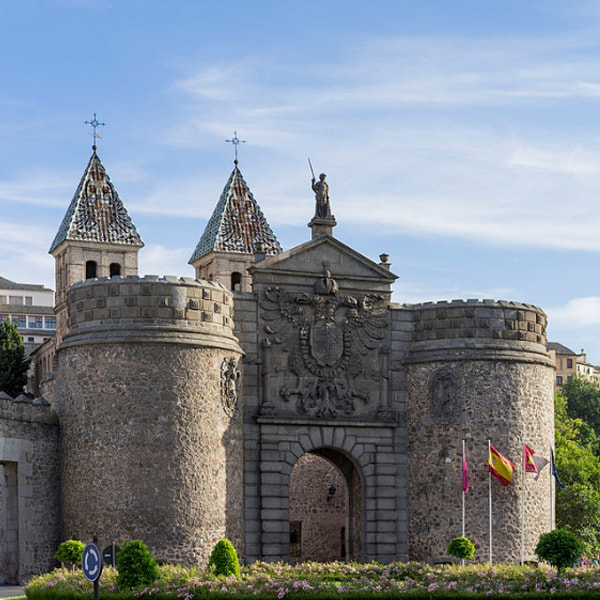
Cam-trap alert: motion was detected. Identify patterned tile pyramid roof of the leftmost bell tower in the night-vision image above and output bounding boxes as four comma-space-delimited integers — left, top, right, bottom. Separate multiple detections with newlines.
50, 147, 144, 252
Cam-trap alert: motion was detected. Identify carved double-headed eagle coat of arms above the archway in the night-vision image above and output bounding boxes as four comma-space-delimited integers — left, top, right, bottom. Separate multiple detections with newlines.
260, 270, 388, 418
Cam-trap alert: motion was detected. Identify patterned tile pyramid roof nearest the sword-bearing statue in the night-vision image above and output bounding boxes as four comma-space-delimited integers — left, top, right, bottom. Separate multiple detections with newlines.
189, 164, 281, 264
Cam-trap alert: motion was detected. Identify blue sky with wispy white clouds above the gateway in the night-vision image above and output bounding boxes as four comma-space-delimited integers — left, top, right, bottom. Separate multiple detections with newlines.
0, 0, 600, 364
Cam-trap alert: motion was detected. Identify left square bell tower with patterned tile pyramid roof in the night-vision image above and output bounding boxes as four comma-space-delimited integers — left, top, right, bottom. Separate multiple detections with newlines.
49, 142, 144, 347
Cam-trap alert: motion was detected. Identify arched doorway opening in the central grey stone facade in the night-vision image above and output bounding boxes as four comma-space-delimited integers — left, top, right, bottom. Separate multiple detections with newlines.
289, 448, 362, 562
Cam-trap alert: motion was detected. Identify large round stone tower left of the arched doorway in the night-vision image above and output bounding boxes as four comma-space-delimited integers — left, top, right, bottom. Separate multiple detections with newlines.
57, 276, 243, 565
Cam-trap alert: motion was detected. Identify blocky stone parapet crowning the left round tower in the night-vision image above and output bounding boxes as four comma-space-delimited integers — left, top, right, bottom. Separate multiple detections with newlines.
61, 275, 239, 350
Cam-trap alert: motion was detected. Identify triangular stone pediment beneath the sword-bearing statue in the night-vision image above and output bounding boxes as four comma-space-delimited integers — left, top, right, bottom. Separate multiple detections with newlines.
250, 235, 397, 286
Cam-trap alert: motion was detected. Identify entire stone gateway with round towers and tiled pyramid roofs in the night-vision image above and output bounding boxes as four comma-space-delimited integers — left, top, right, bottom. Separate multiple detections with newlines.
0, 148, 554, 581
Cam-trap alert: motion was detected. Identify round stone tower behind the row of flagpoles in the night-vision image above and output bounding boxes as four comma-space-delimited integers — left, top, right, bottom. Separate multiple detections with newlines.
406, 300, 554, 563
